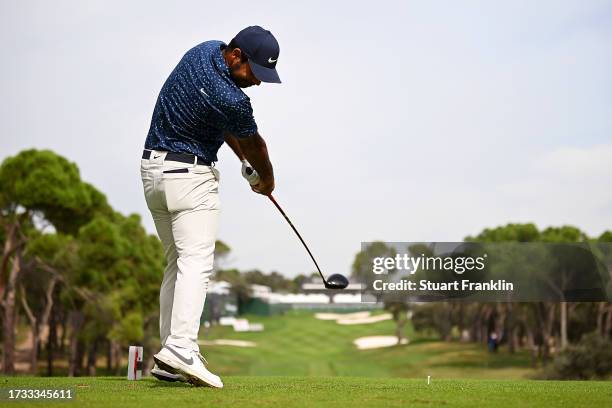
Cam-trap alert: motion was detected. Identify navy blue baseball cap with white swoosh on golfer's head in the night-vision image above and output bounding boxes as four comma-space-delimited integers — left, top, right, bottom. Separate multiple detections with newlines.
232, 26, 281, 84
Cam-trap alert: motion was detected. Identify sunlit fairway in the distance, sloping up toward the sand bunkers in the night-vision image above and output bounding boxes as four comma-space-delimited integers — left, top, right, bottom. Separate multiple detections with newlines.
202, 312, 534, 379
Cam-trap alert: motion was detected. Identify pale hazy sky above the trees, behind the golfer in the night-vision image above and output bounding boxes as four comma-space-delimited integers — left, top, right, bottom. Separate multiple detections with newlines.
0, 1, 612, 276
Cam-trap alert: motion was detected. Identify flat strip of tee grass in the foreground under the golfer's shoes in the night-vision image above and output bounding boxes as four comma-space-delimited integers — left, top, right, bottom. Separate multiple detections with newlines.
2, 376, 612, 408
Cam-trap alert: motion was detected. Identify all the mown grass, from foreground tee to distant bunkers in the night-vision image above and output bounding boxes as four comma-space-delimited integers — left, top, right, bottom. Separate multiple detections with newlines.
5, 312, 612, 408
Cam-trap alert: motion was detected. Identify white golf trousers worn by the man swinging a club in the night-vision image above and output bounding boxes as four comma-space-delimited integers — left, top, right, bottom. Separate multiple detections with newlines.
141, 151, 220, 350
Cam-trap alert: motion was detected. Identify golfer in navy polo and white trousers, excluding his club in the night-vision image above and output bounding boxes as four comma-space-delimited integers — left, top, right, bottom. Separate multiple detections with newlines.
141, 26, 280, 388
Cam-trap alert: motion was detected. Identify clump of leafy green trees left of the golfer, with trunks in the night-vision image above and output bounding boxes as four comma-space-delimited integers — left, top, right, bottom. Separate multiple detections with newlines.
0, 149, 164, 374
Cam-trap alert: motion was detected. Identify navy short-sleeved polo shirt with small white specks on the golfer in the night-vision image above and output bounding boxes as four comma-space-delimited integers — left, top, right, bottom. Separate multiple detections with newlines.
145, 41, 257, 161
